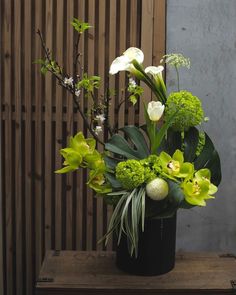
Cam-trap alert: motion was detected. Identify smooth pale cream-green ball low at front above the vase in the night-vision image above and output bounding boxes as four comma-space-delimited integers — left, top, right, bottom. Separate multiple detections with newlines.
146, 178, 169, 201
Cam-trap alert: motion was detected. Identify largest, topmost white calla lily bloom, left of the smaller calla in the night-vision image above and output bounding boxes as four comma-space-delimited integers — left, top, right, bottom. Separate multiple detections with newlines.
109, 47, 144, 75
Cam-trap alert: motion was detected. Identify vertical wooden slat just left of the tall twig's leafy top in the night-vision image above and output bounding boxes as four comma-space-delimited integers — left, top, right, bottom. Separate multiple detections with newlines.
66, 1, 74, 249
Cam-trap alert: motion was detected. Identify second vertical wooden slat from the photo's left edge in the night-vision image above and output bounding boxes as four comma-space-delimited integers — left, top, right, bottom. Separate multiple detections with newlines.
14, 1, 24, 295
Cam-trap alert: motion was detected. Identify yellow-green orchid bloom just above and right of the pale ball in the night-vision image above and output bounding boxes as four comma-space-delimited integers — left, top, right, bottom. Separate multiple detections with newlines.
160, 149, 194, 180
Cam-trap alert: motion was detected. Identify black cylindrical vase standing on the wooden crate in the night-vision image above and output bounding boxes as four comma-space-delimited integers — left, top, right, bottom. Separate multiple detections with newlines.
116, 215, 176, 276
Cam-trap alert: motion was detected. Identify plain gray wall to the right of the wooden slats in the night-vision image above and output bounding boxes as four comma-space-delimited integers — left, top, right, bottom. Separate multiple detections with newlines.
167, 0, 236, 253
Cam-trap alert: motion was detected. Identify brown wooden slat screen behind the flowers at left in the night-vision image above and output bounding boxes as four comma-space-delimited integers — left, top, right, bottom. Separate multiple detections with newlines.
0, 0, 165, 295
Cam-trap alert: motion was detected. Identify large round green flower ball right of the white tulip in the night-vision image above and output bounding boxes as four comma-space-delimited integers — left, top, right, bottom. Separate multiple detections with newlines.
165, 90, 204, 131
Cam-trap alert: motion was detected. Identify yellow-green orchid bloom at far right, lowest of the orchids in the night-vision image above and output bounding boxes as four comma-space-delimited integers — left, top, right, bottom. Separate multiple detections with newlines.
181, 168, 217, 206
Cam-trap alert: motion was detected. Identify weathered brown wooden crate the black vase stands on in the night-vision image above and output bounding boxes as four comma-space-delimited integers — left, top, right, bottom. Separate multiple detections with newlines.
36, 251, 236, 295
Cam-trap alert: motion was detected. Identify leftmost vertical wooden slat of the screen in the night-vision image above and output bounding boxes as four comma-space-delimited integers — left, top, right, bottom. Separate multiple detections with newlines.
3, 1, 13, 295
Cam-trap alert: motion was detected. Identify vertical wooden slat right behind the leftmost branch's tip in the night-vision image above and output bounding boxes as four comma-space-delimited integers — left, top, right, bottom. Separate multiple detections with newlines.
34, 1, 43, 277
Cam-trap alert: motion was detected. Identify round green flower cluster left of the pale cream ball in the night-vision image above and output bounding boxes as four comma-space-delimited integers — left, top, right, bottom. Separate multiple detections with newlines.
116, 160, 144, 190
